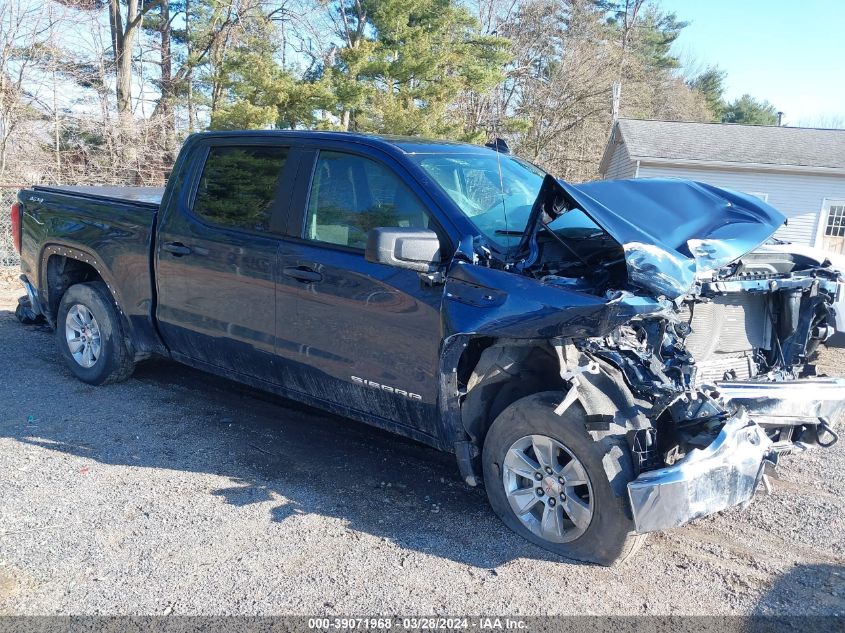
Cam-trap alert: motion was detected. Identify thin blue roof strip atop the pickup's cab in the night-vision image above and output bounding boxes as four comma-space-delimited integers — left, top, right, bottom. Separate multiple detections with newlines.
192, 130, 492, 154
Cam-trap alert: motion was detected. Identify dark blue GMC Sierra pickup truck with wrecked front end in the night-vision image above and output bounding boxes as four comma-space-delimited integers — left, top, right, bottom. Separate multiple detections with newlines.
12, 131, 845, 564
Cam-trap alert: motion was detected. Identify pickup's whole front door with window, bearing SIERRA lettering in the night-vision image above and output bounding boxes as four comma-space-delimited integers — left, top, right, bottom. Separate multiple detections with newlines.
277, 150, 442, 437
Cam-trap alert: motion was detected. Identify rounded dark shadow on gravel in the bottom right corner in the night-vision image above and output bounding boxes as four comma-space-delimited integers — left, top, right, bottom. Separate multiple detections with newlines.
748, 564, 845, 633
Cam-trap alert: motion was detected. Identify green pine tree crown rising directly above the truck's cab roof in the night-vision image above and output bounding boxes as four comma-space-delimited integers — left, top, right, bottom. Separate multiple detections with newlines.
326, 0, 508, 137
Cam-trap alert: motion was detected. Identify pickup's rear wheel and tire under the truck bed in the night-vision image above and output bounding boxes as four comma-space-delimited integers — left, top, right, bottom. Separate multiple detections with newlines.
56, 281, 135, 385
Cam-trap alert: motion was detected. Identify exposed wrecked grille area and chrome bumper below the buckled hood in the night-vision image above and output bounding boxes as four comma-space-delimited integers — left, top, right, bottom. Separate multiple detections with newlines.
544, 264, 845, 532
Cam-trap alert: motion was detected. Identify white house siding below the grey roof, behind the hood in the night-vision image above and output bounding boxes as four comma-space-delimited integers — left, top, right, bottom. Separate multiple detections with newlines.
632, 162, 845, 246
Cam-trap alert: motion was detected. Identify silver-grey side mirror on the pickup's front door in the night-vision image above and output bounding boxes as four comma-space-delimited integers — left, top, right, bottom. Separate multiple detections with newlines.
364, 227, 440, 273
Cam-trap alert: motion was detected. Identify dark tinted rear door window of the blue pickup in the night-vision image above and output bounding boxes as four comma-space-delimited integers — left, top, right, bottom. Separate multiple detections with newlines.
193, 146, 288, 232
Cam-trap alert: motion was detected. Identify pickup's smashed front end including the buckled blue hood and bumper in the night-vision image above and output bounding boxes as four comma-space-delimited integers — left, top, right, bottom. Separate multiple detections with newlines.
502, 175, 845, 532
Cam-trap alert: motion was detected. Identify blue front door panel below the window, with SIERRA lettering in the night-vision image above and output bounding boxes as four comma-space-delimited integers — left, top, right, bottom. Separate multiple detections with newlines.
277, 243, 442, 437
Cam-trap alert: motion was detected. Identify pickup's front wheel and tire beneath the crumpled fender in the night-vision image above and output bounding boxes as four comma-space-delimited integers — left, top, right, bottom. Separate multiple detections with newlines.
482, 392, 646, 565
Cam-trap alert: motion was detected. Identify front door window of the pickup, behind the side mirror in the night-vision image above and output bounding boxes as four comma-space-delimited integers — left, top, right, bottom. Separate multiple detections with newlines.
305, 152, 430, 248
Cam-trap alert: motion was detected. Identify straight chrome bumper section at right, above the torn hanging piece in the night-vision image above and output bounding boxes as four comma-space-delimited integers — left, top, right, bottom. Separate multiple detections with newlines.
716, 378, 845, 426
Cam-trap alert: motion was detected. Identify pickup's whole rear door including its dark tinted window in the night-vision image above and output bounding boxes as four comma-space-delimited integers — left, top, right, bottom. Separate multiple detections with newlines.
156, 145, 291, 379
